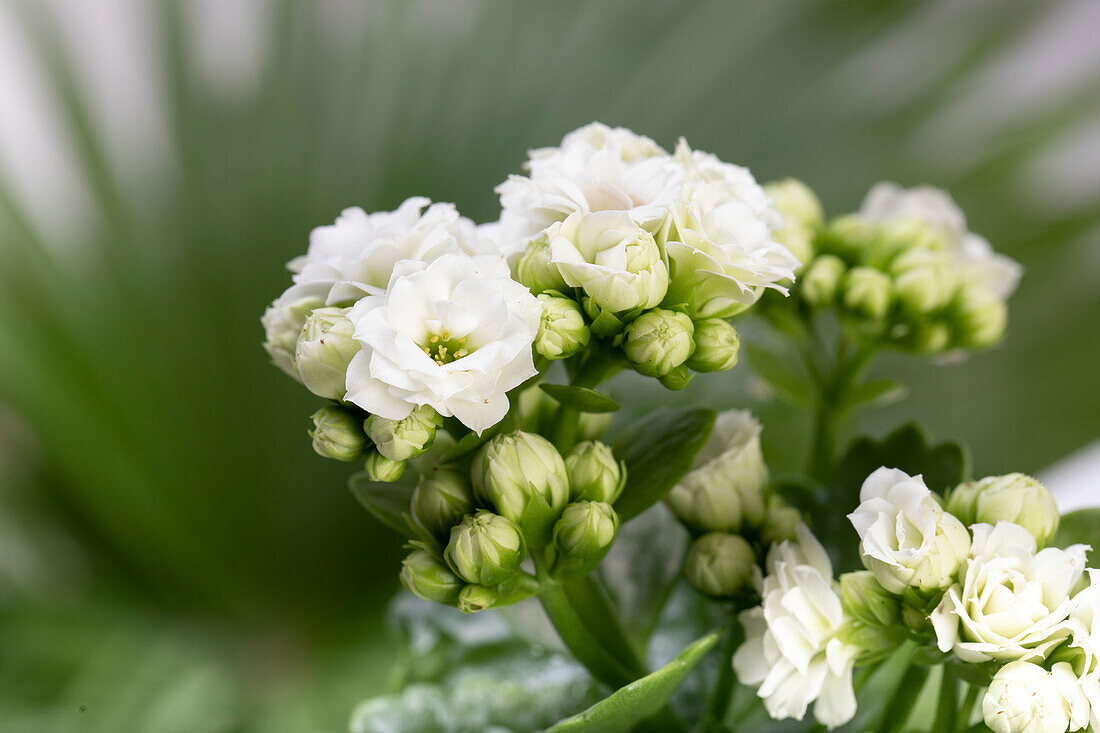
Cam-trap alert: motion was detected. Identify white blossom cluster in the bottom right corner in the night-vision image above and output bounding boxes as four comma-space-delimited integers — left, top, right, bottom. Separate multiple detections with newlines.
734, 467, 1100, 733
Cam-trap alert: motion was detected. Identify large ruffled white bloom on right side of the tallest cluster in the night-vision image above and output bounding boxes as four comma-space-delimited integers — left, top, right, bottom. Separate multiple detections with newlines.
663, 181, 799, 318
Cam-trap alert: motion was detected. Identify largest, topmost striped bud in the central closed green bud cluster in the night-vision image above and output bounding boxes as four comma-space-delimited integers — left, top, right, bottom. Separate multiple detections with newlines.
471, 430, 569, 523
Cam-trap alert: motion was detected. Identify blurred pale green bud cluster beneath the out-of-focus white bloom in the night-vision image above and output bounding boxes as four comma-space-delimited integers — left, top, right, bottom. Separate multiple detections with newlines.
783, 182, 1015, 354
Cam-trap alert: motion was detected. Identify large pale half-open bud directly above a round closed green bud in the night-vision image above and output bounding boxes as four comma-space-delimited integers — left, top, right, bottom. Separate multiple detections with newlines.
664, 409, 768, 533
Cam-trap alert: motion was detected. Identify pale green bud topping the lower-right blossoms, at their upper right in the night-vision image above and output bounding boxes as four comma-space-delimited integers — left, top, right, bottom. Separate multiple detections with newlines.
947, 473, 1059, 547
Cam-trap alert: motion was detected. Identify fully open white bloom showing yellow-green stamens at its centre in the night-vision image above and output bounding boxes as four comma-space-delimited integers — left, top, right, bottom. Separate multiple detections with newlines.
344, 254, 541, 433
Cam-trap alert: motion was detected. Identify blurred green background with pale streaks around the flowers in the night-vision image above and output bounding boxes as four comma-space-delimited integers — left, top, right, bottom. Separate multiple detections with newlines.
0, 0, 1100, 733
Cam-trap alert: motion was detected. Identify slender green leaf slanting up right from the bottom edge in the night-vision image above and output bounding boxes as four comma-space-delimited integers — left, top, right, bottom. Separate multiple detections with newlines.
547, 632, 718, 733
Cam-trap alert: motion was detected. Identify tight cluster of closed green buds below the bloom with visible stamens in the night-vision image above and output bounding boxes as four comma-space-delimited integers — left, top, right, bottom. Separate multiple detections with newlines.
402, 430, 626, 613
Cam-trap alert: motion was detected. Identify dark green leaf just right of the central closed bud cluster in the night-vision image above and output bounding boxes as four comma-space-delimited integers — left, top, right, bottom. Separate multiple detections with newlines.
615, 407, 715, 522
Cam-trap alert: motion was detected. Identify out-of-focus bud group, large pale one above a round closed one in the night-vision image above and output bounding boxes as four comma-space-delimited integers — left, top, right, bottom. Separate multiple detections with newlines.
664, 409, 802, 599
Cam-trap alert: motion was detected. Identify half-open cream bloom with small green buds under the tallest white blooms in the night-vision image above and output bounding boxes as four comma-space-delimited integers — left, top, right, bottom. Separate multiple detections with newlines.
514, 211, 740, 390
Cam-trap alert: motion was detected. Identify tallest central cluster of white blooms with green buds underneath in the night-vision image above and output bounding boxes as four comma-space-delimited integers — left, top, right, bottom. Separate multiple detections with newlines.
501, 123, 799, 389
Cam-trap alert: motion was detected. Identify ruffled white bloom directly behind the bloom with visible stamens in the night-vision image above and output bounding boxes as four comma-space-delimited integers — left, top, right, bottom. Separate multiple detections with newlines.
287, 196, 488, 305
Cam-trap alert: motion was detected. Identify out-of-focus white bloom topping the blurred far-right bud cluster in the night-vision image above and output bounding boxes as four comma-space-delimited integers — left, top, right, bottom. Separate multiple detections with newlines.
859, 180, 1023, 300
